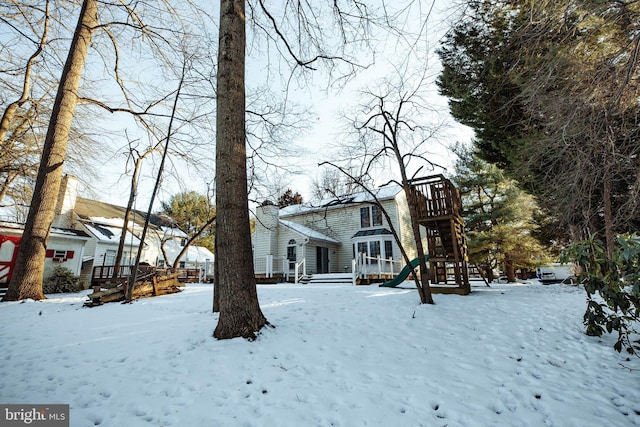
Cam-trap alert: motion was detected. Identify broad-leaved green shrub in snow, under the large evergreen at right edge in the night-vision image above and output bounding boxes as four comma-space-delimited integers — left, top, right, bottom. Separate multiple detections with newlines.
564, 235, 640, 355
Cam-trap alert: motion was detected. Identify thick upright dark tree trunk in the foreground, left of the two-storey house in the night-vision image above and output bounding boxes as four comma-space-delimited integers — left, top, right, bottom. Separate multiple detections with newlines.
213, 0, 268, 339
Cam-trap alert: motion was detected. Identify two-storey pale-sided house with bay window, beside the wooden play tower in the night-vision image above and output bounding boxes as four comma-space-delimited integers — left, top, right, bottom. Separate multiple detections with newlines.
252, 185, 426, 278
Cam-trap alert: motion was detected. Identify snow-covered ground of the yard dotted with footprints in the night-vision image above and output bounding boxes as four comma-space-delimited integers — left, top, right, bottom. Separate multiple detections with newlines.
0, 283, 640, 427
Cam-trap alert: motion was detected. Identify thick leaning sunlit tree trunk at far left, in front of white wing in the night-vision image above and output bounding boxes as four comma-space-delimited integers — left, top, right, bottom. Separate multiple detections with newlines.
3, 0, 98, 301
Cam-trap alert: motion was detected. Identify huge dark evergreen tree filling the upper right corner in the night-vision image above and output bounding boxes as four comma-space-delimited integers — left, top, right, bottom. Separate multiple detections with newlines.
439, 0, 640, 251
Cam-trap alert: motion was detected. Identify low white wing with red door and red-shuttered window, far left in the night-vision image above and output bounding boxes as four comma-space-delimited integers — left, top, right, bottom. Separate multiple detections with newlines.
0, 222, 91, 295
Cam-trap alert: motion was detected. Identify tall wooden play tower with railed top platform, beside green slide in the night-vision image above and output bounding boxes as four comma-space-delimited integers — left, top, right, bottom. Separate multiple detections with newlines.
411, 175, 471, 295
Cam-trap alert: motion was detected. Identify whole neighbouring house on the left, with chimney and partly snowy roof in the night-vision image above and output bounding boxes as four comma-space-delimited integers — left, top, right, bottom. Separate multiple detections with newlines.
0, 175, 213, 286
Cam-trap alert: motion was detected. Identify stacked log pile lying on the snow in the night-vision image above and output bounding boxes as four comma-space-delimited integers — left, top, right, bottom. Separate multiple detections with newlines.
84, 273, 183, 307
